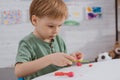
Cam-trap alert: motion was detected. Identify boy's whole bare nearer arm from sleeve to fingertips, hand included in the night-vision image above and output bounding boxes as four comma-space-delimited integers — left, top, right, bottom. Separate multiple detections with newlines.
15, 53, 75, 77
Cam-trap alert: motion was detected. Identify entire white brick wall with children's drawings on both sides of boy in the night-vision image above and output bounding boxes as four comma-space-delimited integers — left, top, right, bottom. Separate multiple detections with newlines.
0, 0, 120, 80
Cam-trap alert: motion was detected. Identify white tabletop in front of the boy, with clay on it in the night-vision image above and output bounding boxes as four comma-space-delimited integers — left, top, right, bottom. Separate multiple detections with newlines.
33, 59, 120, 80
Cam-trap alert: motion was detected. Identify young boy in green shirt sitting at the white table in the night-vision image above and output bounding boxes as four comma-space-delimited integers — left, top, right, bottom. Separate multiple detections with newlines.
15, 0, 82, 80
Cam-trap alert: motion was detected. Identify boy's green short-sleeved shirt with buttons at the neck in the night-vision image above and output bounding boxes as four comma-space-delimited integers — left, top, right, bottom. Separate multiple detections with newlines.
16, 33, 66, 80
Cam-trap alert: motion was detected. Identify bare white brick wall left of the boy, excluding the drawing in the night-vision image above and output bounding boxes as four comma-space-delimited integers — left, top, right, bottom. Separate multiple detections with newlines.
0, 0, 33, 67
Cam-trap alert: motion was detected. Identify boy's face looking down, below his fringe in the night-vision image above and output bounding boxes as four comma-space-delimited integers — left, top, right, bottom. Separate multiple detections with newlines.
33, 17, 65, 42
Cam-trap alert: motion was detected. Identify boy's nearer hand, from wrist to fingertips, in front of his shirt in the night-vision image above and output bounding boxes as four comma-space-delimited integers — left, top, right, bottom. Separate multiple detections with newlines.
48, 53, 75, 67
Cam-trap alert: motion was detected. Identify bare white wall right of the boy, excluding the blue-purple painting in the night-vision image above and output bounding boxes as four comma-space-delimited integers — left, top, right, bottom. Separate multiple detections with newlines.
62, 0, 115, 61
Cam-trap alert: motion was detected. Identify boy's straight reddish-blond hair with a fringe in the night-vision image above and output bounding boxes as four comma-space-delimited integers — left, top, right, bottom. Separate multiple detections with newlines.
29, 0, 68, 20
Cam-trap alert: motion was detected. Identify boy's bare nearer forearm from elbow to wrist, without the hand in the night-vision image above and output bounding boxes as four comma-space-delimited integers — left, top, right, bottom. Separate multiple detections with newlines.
15, 56, 51, 77
